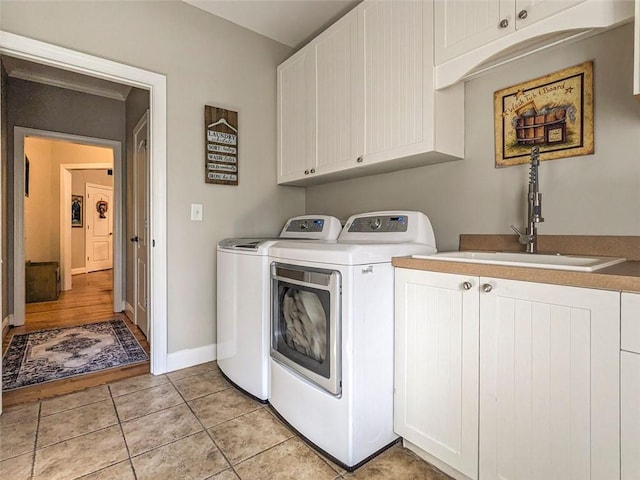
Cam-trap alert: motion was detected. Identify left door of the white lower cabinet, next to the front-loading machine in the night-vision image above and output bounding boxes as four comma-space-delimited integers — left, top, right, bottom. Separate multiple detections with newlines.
394, 268, 479, 479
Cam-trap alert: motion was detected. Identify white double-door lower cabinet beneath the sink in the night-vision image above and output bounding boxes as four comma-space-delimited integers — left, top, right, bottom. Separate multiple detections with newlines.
395, 269, 620, 480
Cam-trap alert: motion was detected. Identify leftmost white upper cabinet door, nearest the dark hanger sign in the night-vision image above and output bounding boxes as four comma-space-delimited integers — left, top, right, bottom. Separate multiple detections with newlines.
278, 48, 316, 183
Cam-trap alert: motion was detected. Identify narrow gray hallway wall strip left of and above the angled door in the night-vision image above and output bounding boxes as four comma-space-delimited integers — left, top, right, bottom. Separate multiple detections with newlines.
124, 88, 149, 306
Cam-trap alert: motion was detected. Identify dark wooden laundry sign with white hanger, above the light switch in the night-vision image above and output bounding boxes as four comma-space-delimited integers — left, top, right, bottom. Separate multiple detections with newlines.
204, 105, 238, 185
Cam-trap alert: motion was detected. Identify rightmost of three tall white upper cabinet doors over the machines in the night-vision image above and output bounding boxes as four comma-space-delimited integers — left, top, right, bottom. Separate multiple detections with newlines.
359, 0, 428, 163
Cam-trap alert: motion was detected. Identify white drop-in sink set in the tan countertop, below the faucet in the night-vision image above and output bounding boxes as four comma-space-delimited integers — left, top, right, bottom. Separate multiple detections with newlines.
413, 251, 626, 272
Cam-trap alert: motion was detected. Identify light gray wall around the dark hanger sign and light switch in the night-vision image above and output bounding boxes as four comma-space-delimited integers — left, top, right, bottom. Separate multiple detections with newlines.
0, 1, 305, 353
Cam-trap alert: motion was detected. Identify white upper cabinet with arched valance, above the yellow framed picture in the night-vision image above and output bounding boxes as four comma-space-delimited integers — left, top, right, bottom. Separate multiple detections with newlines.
434, 0, 634, 89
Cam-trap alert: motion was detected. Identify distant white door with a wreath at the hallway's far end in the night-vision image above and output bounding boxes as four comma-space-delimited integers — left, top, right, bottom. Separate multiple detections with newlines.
85, 183, 113, 273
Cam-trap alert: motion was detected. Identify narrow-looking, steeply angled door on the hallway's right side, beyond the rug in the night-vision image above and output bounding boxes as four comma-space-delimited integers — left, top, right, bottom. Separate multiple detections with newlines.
131, 110, 149, 337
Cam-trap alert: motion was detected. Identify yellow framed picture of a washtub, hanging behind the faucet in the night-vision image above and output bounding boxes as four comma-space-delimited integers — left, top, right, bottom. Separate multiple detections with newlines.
494, 61, 594, 167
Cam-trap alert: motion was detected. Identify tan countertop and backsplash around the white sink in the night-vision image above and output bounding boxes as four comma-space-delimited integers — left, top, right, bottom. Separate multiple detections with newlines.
392, 235, 640, 293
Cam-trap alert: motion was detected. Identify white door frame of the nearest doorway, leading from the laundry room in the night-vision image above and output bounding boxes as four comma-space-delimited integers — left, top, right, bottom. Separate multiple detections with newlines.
0, 30, 168, 375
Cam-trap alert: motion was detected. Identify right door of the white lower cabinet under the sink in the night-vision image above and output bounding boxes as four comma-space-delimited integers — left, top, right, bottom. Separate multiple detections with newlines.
480, 278, 620, 480
